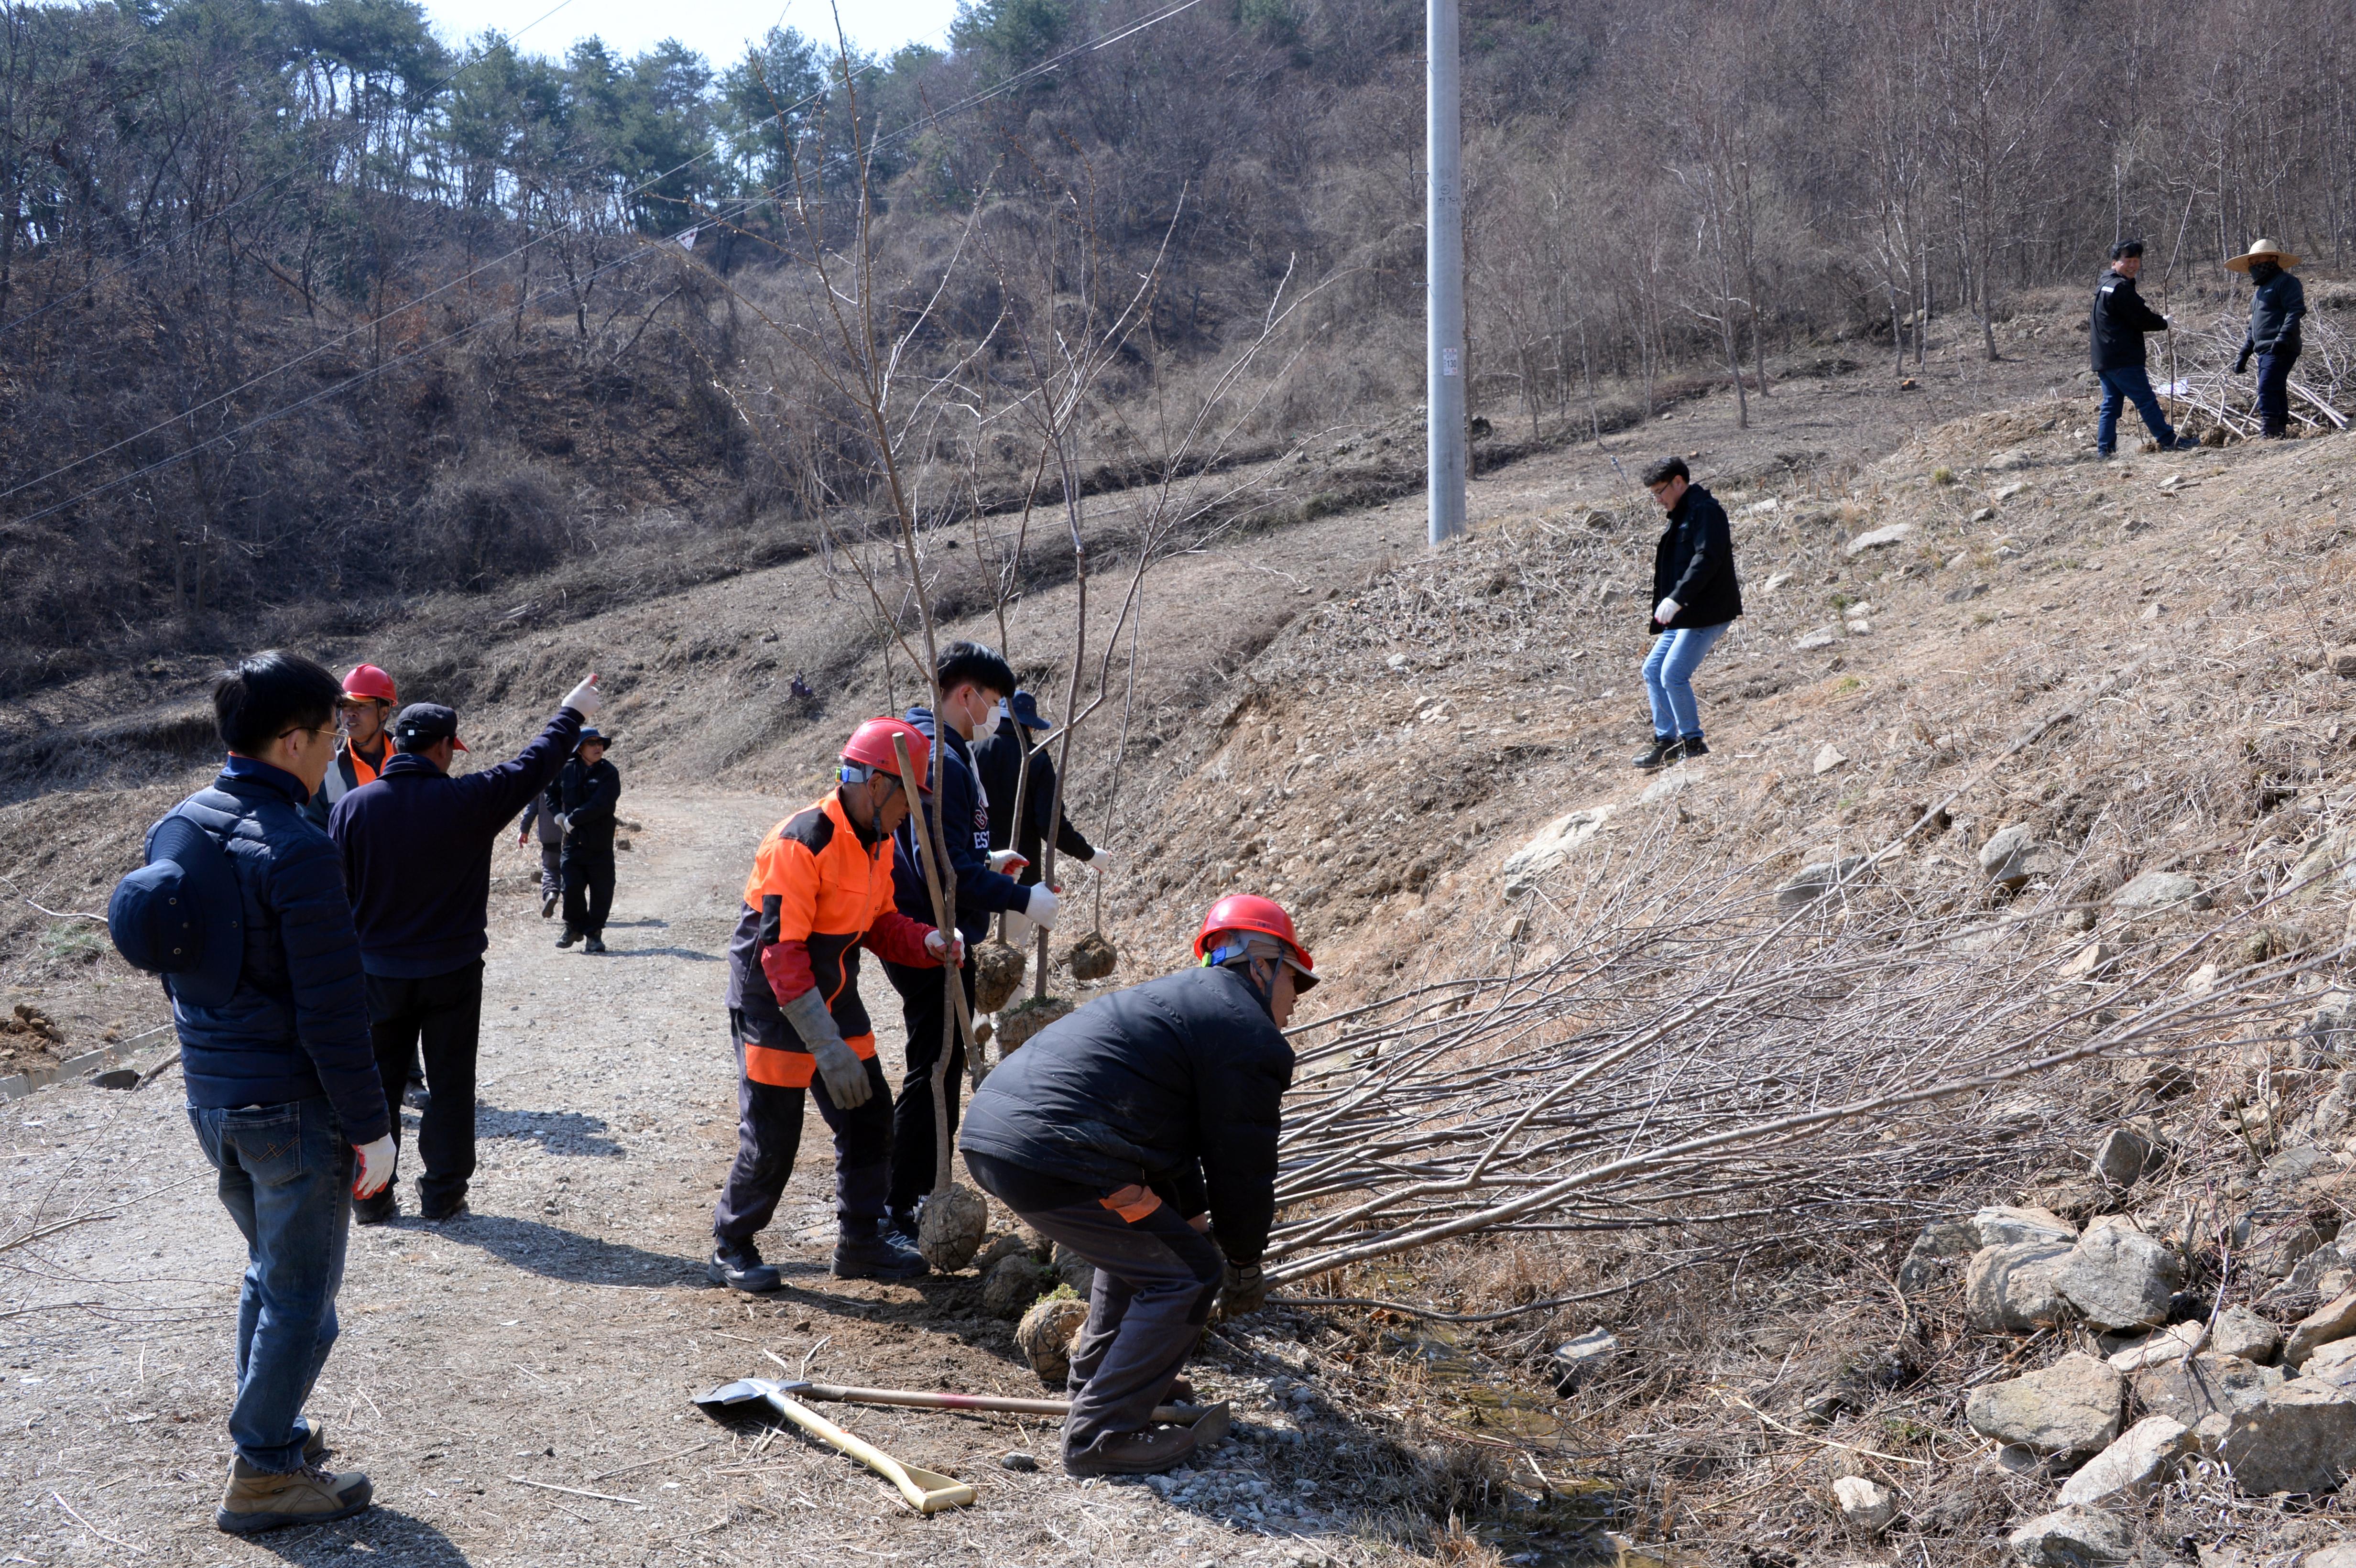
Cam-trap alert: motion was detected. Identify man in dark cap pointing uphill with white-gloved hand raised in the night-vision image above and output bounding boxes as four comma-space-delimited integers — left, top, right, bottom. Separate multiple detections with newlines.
327, 675, 599, 1224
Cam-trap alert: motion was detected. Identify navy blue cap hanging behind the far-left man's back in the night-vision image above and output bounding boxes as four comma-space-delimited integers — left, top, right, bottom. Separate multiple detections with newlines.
106, 812, 245, 1008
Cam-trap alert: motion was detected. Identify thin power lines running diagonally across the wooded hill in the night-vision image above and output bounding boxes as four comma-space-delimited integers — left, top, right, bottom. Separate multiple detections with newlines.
0, 0, 1201, 523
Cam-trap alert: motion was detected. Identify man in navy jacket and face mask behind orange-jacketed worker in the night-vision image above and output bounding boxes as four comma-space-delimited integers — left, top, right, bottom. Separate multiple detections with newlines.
884, 643, 1056, 1241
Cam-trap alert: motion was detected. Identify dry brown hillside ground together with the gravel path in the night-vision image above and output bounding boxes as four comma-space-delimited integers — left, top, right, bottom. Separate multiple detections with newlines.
13, 315, 2356, 1568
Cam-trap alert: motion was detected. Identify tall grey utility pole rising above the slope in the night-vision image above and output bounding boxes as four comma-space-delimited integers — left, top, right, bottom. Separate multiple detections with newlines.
1423, 0, 1465, 544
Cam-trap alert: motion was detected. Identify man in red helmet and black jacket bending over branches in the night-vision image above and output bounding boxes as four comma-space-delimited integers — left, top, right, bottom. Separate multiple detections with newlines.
957, 894, 1317, 1476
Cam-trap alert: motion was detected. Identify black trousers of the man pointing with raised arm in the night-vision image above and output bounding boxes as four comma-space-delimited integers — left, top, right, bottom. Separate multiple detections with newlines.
368, 958, 483, 1210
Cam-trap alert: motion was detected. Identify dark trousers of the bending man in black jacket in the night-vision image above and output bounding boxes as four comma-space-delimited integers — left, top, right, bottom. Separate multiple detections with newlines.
966, 1154, 1225, 1458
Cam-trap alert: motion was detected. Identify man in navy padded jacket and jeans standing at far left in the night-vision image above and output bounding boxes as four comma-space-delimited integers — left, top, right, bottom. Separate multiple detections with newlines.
148, 652, 401, 1535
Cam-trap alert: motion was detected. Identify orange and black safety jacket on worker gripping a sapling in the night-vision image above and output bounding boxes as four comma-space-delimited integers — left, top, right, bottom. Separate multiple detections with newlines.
728, 794, 940, 1088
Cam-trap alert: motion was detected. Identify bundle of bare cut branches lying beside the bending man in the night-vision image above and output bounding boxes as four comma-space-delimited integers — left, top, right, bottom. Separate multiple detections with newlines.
1267, 800, 2330, 1300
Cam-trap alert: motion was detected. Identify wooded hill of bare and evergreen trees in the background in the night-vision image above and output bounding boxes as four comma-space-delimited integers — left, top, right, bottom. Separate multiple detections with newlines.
0, 0, 2356, 695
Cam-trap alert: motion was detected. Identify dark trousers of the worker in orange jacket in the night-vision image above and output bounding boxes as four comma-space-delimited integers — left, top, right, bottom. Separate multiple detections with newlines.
711, 1010, 891, 1241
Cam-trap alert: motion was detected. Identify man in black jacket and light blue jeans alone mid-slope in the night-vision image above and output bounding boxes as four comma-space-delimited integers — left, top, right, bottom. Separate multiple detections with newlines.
1635, 457, 1744, 770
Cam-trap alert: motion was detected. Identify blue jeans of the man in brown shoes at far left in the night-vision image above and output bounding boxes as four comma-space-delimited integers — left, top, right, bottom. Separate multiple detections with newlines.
188, 1097, 353, 1474
